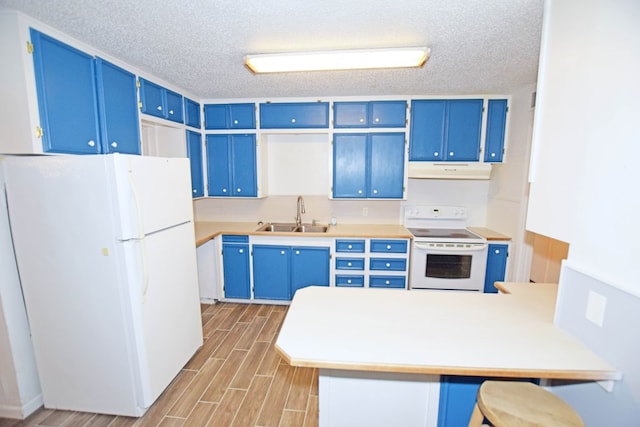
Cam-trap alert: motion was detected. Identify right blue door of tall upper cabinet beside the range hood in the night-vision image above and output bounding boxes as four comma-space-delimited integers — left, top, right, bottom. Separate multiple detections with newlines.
367, 133, 405, 199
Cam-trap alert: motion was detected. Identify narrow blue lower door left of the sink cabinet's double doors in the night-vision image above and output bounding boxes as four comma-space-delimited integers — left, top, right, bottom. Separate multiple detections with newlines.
222, 243, 251, 299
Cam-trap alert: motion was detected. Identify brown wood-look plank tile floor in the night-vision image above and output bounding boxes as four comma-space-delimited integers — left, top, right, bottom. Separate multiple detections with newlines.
0, 303, 318, 427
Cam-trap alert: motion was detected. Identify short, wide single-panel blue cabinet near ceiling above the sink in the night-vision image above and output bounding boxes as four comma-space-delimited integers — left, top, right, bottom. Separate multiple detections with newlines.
260, 102, 329, 129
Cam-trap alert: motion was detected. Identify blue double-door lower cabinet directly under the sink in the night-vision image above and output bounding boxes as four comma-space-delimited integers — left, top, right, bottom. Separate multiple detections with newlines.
253, 244, 330, 300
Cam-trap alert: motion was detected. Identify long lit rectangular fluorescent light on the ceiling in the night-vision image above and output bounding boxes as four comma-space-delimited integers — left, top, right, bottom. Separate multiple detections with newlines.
244, 47, 430, 73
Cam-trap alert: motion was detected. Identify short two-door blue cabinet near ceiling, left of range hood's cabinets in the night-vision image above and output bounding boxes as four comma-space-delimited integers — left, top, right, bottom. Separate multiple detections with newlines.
333, 101, 407, 128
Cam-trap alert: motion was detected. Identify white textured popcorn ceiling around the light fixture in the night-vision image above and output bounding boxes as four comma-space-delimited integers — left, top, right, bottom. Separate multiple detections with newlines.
0, 0, 543, 99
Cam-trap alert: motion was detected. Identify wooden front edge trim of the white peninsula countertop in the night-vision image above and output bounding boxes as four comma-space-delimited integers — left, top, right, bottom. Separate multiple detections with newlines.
274, 344, 622, 381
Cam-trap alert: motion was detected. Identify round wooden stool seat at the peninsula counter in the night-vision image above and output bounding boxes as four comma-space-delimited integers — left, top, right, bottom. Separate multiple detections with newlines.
469, 381, 584, 427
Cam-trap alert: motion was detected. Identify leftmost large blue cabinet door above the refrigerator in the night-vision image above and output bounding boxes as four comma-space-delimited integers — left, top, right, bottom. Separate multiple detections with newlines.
29, 29, 101, 154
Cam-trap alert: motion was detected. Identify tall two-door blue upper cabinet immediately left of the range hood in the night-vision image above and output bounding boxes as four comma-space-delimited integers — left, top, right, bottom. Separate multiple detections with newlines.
333, 132, 405, 199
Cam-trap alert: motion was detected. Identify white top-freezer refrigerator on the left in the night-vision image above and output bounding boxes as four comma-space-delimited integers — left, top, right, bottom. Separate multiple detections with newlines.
2, 154, 202, 416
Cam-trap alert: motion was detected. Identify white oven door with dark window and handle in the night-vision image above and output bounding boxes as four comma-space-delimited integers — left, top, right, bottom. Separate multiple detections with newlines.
409, 241, 487, 291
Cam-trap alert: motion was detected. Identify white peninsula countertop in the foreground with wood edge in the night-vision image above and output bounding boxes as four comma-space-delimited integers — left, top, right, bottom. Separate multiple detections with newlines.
276, 284, 620, 380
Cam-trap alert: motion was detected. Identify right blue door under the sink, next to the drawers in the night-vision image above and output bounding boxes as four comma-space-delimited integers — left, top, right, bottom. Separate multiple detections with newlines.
291, 246, 330, 298
